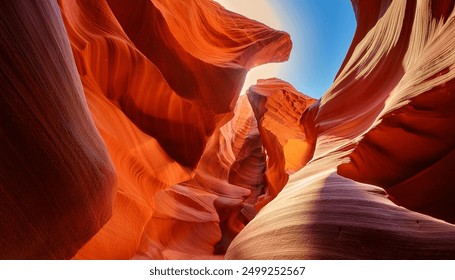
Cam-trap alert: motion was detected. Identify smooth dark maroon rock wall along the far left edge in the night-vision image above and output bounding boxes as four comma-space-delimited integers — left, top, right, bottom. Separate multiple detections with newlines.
0, 0, 115, 259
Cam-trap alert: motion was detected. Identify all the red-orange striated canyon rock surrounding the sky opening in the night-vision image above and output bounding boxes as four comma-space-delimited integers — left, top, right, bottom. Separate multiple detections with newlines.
0, 0, 455, 259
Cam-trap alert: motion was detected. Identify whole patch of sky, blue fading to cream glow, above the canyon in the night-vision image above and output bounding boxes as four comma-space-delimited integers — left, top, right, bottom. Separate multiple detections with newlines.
216, 0, 356, 98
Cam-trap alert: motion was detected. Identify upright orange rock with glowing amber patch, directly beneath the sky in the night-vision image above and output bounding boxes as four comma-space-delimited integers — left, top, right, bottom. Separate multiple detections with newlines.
247, 78, 316, 209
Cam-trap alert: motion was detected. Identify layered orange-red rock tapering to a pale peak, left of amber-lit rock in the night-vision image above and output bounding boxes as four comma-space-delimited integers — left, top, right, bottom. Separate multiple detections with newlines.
135, 96, 265, 259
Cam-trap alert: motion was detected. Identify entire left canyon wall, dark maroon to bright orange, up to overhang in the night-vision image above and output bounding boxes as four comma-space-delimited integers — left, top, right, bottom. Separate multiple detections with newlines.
0, 0, 291, 259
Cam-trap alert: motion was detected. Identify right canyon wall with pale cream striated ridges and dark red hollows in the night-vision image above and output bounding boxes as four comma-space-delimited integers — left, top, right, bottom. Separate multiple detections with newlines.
226, 1, 455, 259
